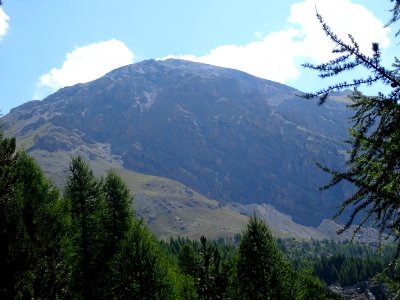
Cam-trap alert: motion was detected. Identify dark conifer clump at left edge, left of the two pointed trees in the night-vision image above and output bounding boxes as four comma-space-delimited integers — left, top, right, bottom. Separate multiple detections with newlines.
0, 132, 68, 299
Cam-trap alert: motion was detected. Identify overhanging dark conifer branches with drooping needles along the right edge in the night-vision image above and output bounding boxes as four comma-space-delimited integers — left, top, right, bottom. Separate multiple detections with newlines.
304, 0, 400, 248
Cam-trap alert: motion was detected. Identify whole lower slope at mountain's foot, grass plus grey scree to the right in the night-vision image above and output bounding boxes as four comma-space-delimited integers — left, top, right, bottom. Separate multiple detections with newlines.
19, 145, 388, 242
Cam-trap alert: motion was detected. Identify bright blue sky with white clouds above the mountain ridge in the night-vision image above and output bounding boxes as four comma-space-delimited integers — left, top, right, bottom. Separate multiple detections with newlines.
0, 0, 398, 114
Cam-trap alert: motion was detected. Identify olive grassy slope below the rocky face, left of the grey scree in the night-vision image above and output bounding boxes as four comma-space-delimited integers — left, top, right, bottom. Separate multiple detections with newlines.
32, 147, 248, 239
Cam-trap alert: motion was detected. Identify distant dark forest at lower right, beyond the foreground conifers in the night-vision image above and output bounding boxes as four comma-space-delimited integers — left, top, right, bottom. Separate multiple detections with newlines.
278, 239, 395, 286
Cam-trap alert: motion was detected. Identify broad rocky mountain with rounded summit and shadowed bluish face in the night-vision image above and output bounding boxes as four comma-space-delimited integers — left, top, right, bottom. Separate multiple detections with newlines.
2, 59, 349, 226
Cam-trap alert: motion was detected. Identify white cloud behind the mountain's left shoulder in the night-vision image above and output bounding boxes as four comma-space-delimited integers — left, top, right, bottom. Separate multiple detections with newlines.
35, 39, 134, 98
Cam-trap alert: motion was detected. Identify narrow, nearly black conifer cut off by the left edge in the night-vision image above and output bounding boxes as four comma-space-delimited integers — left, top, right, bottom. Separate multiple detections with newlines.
0, 131, 31, 299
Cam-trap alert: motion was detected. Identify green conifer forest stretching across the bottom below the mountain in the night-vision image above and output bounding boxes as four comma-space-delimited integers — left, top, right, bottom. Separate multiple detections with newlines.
0, 132, 394, 299
